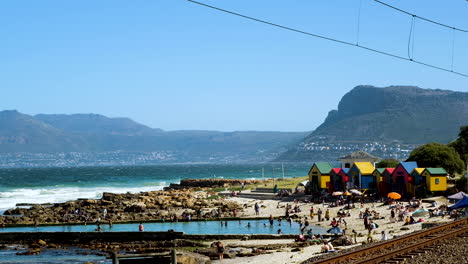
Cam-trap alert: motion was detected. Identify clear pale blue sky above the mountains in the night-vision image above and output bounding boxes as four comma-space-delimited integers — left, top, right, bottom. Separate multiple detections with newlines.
0, 0, 468, 131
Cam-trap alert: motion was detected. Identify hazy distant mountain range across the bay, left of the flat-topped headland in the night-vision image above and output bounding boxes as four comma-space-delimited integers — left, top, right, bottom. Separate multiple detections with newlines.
0, 110, 308, 161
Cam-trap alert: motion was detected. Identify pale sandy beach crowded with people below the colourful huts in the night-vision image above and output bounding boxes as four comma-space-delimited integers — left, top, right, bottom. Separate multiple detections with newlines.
207, 197, 453, 264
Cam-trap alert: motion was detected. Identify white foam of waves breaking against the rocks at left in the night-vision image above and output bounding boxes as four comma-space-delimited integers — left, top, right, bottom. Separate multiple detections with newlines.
0, 182, 172, 214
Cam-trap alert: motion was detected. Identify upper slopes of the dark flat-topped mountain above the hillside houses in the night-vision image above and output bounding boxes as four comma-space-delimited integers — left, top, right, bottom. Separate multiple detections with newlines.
309, 85, 468, 143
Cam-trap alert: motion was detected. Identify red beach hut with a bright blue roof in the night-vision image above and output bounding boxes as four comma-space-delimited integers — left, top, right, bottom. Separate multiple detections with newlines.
391, 161, 418, 196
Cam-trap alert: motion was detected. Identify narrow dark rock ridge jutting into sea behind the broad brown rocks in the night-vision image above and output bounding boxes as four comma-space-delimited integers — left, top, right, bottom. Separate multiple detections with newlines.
165, 179, 260, 190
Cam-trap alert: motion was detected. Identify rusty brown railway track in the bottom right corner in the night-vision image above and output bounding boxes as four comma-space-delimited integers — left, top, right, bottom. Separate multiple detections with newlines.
303, 218, 468, 264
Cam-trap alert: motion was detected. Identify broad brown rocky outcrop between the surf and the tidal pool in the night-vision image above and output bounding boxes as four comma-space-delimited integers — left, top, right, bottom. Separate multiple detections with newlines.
0, 189, 243, 226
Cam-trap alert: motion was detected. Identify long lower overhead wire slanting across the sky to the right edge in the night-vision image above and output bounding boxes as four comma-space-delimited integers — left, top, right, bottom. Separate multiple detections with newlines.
187, 0, 468, 77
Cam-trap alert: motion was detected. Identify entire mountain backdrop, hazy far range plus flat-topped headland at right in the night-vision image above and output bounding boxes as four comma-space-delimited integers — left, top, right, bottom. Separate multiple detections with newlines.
0, 85, 468, 165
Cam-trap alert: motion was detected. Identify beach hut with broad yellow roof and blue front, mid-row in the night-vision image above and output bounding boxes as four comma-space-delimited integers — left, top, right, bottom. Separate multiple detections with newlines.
347, 162, 377, 190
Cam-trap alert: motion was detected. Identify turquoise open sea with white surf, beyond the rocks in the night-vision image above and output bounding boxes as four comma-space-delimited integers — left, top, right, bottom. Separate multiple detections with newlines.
0, 164, 310, 214
